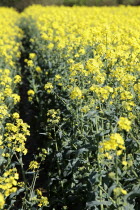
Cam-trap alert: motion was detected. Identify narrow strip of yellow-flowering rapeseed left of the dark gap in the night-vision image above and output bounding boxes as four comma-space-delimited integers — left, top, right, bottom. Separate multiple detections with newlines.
0, 8, 48, 209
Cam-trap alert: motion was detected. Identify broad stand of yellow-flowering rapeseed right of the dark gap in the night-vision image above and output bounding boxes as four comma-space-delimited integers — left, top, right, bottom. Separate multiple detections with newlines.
22, 6, 140, 210
